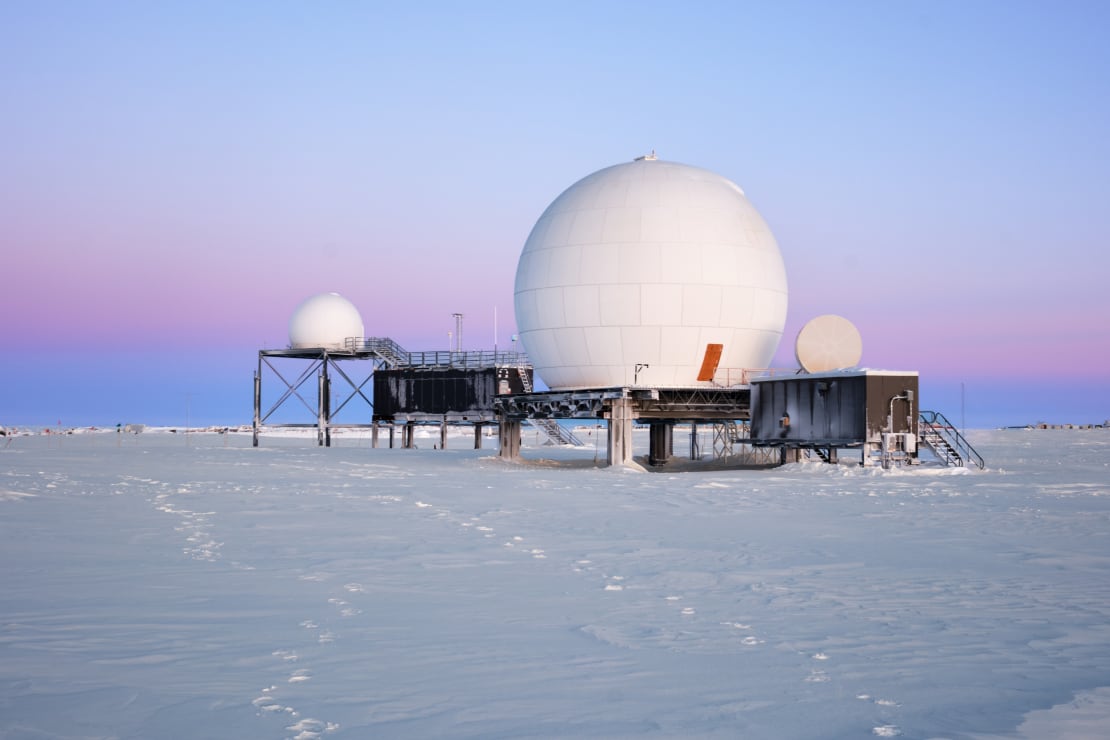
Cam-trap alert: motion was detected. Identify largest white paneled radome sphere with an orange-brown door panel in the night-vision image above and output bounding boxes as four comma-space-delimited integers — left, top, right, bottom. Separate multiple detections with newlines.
515, 158, 787, 388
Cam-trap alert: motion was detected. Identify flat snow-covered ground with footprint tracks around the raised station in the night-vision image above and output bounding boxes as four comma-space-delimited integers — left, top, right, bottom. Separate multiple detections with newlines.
0, 429, 1110, 740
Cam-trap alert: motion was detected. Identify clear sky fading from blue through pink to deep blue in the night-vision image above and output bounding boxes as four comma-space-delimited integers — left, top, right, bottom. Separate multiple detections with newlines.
0, 0, 1110, 426
